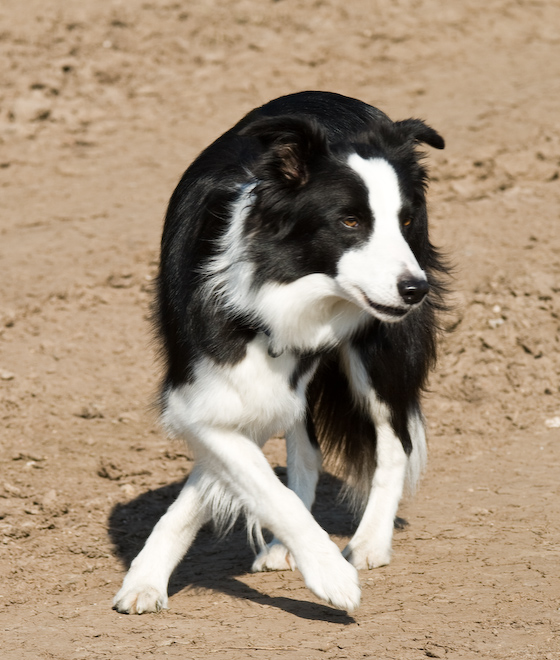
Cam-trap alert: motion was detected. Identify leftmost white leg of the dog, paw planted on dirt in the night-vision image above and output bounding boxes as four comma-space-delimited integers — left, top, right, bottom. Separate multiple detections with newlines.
113, 465, 210, 614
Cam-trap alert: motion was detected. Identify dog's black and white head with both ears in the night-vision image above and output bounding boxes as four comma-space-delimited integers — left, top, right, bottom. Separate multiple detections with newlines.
241, 117, 443, 322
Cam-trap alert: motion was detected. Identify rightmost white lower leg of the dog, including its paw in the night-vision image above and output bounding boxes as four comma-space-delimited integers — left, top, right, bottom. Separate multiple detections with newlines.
343, 415, 408, 569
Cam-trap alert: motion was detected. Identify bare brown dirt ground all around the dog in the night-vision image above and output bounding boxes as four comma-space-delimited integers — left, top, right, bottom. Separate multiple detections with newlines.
0, 0, 560, 660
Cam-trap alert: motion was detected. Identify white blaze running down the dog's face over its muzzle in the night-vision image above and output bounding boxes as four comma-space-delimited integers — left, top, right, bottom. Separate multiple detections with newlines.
336, 154, 425, 320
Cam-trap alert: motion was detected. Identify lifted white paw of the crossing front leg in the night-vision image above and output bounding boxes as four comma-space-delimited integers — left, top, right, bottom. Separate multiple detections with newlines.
297, 541, 361, 612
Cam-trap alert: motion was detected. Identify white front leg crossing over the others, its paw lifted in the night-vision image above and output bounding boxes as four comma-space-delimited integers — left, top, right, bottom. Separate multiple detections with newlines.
193, 427, 360, 611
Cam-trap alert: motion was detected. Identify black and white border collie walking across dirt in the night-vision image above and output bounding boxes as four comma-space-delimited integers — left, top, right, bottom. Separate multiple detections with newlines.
114, 92, 446, 614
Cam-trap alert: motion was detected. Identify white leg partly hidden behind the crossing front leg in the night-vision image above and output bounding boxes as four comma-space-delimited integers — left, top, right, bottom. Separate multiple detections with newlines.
252, 421, 321, 572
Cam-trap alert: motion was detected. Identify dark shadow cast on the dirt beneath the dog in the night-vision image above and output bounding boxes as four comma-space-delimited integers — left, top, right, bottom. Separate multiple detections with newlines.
109, 468, 364, 624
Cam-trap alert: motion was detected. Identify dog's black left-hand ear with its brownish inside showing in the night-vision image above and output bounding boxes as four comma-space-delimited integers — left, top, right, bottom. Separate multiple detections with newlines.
239, 115, 328, 188
